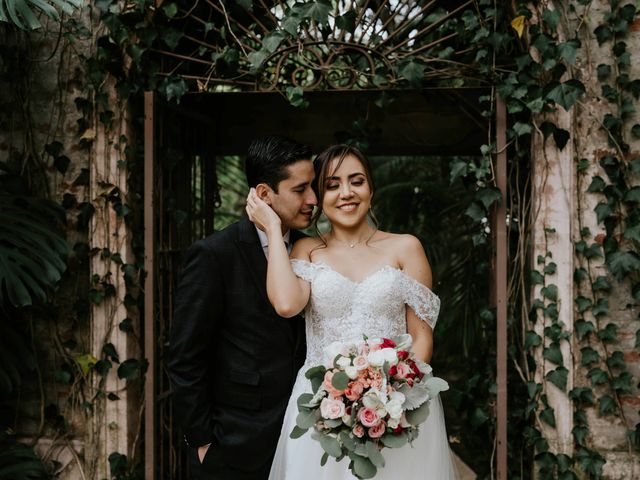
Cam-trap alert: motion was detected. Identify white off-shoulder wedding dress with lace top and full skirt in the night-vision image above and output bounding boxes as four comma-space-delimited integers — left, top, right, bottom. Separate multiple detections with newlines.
269, 260, 456, 480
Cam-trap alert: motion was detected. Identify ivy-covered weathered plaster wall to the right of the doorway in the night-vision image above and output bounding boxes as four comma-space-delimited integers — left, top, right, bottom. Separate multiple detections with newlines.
532, 1, 640, 479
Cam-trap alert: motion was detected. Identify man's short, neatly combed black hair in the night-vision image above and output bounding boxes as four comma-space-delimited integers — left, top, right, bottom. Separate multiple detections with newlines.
245, 135, 311, 193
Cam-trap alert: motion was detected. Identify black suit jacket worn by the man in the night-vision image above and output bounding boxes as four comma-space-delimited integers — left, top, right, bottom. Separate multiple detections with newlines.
167, 218, 305, 478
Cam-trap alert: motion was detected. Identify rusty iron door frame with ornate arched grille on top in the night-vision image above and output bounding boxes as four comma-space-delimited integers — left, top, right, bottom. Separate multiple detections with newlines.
144, 0, 507, 480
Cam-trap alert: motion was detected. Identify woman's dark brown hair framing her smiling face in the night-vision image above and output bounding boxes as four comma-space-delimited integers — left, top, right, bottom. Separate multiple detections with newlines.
311, 144, 378, 247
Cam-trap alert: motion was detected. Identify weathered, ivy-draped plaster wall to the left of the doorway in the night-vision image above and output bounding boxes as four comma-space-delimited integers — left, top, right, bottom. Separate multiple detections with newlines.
0, 8, 141, 480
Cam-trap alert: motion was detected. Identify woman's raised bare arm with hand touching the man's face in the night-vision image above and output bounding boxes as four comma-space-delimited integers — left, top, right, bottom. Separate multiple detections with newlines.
246, 189, 311, 318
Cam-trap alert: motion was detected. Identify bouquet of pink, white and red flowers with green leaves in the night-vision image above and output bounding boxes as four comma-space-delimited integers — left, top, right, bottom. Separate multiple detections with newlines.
290, 334, 449, 478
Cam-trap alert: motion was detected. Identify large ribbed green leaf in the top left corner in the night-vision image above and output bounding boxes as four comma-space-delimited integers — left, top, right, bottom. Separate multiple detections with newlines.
0, 0, 82, 30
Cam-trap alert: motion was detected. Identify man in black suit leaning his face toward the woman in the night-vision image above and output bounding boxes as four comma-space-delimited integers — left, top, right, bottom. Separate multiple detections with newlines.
167, 136, 316, 480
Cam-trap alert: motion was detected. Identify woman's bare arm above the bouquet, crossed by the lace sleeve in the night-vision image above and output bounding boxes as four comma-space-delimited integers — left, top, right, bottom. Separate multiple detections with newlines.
398, 235, 433, 363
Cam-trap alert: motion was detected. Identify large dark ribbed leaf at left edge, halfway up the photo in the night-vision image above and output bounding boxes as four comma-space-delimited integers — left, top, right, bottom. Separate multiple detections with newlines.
0, 193, 69, 306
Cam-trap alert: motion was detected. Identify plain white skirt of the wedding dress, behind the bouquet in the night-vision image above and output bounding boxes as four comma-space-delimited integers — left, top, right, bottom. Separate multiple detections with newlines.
269, 373, 457, 480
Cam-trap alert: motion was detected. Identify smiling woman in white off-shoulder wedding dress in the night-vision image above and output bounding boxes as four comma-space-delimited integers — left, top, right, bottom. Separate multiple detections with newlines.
247, 145, 456, 480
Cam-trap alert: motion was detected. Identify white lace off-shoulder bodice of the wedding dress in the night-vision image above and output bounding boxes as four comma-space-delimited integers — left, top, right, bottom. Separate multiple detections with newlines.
291, 260, 440, 370
